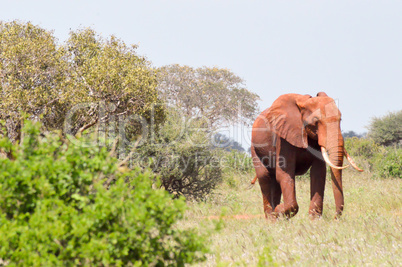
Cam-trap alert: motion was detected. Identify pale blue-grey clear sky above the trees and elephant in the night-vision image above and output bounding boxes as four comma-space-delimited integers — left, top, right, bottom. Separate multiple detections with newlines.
0, 0, 402, 147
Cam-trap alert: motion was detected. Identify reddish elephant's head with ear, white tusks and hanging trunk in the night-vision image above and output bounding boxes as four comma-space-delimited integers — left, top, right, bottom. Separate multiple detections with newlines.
267, 92, 362, 214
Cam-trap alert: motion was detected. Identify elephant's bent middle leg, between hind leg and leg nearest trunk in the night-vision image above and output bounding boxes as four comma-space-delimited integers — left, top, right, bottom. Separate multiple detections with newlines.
275, 139, 299, 218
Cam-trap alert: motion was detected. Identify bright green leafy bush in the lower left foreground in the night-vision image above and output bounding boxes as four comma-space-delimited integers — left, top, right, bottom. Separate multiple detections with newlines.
0, 121, 205, 266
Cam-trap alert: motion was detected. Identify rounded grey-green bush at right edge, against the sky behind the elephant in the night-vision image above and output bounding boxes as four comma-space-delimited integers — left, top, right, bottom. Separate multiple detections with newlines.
368, 110, 402, 146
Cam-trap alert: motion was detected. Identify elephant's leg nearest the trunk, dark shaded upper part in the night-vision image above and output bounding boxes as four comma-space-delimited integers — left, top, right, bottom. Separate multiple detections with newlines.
309, 160, 327, 219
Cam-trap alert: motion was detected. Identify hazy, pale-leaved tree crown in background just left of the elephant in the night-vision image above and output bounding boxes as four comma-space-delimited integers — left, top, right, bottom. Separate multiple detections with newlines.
158, 64, 259, 128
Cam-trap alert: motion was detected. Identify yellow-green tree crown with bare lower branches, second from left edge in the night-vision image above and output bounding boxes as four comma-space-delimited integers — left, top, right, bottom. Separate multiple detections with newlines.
63, 29, 163, 138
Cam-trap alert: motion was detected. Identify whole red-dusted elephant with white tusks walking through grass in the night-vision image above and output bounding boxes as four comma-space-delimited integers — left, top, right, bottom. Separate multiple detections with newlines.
251, 92, 363, 220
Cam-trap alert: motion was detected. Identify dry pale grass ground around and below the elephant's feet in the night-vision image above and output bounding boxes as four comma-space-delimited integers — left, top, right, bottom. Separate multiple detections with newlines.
179, 169, 402, 266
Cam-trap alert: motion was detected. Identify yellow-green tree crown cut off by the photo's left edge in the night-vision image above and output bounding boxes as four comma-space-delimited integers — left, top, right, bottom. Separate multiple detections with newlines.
0, 21, 68, 142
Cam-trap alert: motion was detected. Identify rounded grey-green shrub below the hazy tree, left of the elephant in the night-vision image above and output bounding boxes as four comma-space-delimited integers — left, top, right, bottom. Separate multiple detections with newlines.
131, 111, 221, 199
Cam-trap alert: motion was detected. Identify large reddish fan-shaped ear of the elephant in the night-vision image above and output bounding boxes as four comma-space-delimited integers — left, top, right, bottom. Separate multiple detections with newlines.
267, 94, 311, 148
